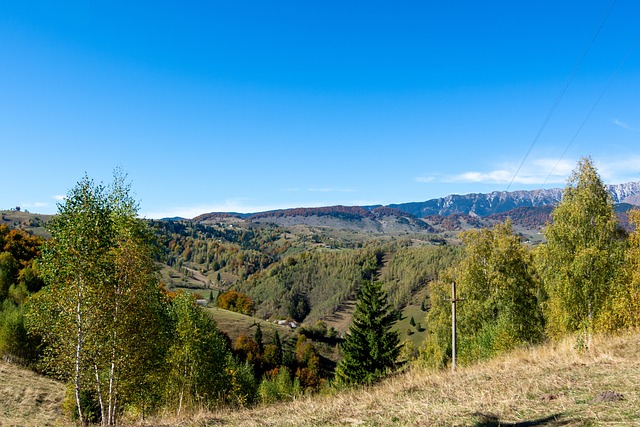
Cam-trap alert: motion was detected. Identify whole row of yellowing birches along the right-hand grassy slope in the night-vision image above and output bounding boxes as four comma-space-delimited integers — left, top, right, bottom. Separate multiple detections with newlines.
422, 158, 640, 366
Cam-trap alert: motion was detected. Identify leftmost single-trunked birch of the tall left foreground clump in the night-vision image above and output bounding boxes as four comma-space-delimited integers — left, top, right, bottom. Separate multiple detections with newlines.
28, 176, 114, 424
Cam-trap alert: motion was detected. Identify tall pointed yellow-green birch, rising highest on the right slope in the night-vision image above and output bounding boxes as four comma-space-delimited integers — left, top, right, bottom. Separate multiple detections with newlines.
538, 157, 624, 340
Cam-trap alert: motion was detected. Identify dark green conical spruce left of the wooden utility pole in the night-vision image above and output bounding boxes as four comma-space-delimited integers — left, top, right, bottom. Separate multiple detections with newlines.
336, 280, 400, 383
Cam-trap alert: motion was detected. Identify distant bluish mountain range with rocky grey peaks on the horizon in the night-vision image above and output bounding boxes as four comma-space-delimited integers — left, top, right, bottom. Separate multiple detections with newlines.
193, 182, 640, 233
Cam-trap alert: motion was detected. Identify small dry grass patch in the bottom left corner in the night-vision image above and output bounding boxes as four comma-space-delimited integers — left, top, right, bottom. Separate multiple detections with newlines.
0, 361, 65, 427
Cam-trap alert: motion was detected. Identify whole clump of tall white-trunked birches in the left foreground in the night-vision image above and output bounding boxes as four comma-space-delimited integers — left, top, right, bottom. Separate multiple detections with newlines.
27, 171, 166, 425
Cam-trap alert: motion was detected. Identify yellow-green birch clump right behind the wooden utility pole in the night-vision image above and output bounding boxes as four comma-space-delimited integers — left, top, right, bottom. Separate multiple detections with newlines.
423, 220, 543, 367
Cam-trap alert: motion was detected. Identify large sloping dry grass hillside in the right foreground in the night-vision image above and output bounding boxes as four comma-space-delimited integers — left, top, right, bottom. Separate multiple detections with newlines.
206, 333, 640, 427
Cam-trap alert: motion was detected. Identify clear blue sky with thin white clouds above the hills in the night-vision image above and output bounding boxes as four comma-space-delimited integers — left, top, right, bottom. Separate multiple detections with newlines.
0, 0, 640, 217
